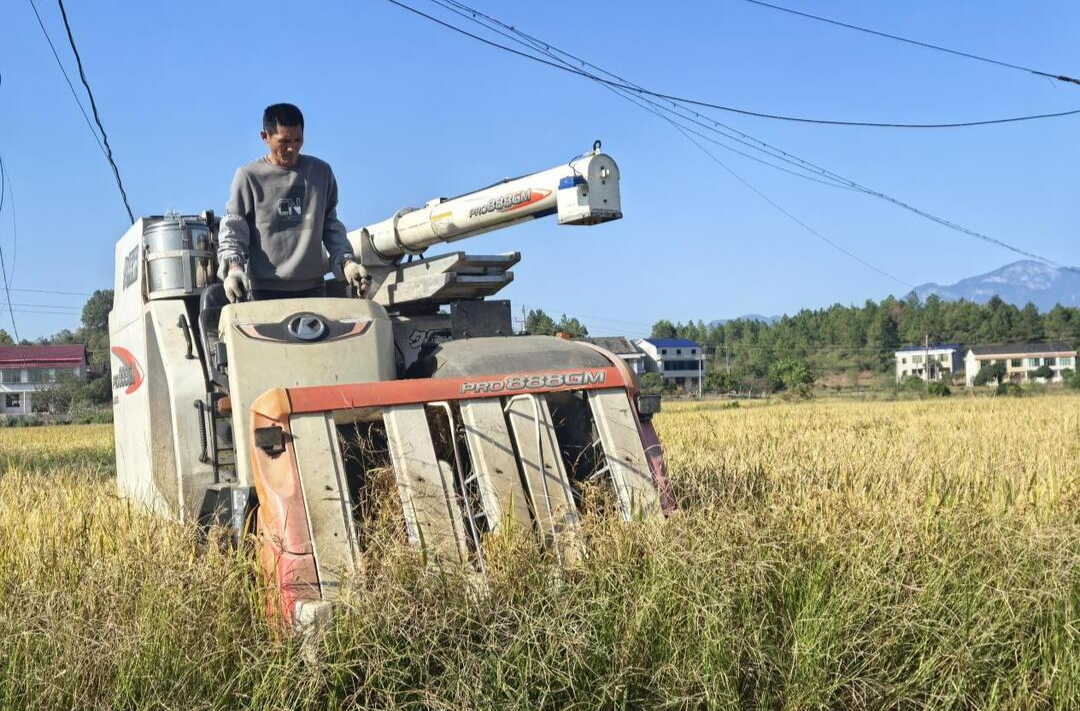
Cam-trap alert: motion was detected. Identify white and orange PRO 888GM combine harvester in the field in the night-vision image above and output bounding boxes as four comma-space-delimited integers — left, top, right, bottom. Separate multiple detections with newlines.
109, 142, 673, 625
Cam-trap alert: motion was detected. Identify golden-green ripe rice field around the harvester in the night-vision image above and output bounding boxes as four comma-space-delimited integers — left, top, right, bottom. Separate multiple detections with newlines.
0, 395, 1080, 710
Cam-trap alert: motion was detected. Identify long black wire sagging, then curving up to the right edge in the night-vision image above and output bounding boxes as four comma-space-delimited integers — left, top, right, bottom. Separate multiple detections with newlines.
387, 0, 1080, 129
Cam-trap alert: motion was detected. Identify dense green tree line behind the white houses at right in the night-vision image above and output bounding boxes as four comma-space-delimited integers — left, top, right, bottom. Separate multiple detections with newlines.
652, 296, 1080, 377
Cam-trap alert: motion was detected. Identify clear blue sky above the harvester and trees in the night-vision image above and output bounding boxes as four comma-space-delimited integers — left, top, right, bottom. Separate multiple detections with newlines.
0, 0, 1080, 337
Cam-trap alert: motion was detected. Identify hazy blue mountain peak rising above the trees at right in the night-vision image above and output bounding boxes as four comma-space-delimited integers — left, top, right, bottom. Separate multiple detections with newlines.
915, 259, 1080, 311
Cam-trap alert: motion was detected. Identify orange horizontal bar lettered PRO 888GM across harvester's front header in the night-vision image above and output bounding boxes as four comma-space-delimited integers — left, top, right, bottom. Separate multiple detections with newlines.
285, 366, 626, 414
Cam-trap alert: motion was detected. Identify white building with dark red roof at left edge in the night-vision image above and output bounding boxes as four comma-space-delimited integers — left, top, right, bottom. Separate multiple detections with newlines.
0, 346, 87, 417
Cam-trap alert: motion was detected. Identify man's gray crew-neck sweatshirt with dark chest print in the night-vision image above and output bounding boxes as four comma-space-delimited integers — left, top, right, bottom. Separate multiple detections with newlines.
217, 156, 352, 291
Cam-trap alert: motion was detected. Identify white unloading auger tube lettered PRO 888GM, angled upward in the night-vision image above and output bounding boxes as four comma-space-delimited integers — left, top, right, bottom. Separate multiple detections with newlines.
349, 142, 622, 264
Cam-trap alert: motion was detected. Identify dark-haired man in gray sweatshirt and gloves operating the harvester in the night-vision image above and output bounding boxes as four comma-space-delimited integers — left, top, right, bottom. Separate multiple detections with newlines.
217, 104, 365, 303
